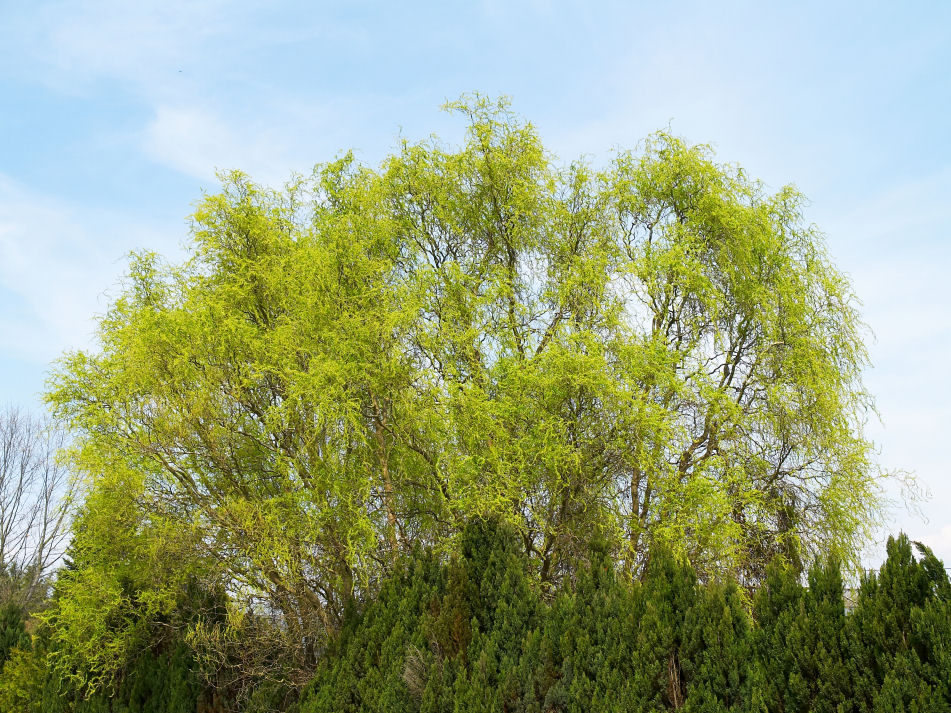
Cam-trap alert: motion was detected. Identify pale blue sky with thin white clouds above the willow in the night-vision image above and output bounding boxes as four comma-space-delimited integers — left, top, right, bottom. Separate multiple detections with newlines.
0, 0, 951, 564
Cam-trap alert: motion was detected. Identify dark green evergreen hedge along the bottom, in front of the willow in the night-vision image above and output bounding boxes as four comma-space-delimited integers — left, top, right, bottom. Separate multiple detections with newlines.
0, 521, 951, 713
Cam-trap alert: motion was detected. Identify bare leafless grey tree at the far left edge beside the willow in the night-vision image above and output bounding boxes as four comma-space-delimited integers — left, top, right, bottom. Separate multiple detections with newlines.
0, 407, 71, 606
